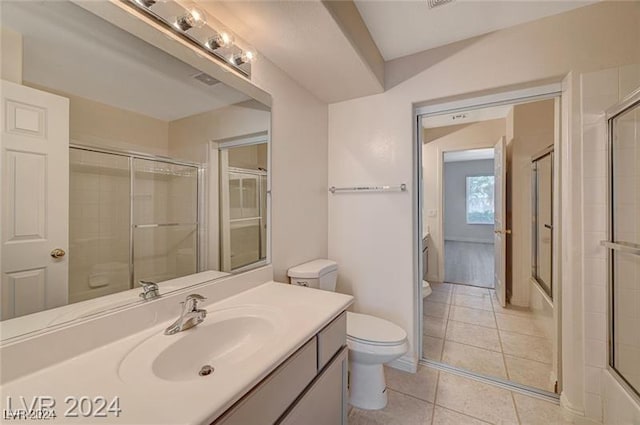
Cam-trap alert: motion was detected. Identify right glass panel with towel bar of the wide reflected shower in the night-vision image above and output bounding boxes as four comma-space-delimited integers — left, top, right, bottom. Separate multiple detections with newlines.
132, 158, 198, 285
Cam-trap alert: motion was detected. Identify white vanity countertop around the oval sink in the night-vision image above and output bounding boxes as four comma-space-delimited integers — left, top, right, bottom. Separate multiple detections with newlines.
2, 282, 353, 424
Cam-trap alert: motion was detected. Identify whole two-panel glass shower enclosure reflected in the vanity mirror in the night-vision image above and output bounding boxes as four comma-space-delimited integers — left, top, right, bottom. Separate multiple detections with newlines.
69, 146, 199, 302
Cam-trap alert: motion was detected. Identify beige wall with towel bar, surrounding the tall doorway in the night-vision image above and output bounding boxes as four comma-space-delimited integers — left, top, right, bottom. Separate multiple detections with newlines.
329, 1, 640, 413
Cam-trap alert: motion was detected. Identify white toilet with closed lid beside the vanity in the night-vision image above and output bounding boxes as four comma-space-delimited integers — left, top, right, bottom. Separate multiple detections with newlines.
288, 260, 409, 410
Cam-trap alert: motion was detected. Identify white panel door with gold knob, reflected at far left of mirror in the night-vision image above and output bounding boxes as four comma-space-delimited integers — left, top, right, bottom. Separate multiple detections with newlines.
0, 80, 69, 320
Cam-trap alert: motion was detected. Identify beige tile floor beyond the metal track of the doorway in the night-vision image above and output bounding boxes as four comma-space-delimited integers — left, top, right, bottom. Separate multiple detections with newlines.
423, 283, 555, 391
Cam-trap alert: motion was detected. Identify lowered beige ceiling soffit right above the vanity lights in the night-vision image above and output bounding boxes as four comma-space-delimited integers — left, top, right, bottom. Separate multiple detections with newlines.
198, 0, 383, 103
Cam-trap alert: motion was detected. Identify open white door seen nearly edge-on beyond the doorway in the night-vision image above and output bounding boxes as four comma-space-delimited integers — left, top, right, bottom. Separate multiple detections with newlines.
493, 137, 511, 307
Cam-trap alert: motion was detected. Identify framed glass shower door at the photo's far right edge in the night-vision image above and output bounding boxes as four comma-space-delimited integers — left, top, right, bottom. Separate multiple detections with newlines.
602, 90, 640, 401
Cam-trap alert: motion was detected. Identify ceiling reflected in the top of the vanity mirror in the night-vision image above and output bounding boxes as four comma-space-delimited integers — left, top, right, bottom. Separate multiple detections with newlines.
2, 1, 249, 121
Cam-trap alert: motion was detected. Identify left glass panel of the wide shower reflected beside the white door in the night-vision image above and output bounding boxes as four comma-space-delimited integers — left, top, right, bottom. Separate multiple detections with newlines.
69, 149, 130, 303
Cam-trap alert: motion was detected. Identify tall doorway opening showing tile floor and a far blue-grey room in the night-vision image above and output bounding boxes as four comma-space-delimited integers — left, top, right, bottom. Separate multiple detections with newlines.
418, 94, 560, 398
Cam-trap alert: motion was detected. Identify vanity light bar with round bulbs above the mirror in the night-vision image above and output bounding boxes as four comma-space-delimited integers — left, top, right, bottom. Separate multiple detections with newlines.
121, 0, 257, 77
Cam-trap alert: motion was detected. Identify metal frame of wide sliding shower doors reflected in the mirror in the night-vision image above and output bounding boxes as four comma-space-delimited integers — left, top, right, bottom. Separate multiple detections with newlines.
69, 140, 206, 289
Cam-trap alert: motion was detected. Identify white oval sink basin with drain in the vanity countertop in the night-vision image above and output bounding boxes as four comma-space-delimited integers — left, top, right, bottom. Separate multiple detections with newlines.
119, 306, 282, 381
